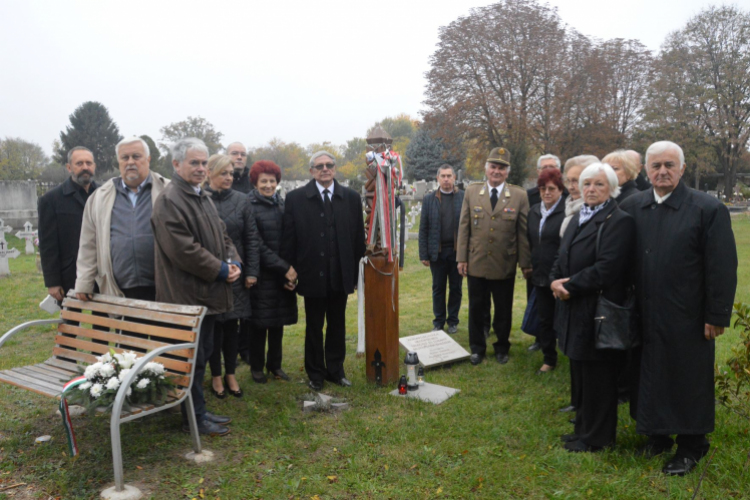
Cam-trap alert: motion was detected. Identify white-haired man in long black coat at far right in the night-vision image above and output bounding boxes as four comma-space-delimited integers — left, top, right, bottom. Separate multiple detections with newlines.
622, 141, 737, 476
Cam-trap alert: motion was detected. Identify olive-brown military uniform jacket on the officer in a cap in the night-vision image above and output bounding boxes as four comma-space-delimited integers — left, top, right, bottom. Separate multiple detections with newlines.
456, 182, 531, 280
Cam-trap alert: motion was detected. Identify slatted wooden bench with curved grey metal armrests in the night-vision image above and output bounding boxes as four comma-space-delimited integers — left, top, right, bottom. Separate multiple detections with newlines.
0, 293, 206, 498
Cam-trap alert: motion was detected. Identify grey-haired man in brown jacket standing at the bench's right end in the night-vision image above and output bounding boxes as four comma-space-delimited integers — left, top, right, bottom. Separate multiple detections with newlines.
151, 138, 240, 436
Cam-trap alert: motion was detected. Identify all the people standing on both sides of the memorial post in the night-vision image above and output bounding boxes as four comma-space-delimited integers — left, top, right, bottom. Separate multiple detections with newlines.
39, 137, 737, 475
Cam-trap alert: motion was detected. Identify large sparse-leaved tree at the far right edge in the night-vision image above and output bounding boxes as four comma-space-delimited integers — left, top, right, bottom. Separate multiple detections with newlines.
649, 6, 750, 198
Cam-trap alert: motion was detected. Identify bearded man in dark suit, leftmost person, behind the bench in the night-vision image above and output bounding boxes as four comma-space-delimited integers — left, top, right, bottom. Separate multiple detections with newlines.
38, 146, 97, 302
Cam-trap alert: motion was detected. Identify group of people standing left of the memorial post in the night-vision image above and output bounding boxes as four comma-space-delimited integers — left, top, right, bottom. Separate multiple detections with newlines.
39, 137, 365, 436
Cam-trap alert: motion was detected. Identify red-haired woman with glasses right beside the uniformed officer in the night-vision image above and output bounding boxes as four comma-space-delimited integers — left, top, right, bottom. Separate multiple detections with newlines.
527, 168, 565, 375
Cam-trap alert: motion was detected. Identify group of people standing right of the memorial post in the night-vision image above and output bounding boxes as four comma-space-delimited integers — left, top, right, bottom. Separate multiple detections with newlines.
419, 141, 737, 475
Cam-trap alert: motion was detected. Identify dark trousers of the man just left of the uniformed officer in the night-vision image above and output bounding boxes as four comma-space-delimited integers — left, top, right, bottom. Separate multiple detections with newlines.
430, 246, 463, 329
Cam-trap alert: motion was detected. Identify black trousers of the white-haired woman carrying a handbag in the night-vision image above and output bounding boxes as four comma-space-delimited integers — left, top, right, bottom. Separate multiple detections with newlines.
570, 350, 625, 446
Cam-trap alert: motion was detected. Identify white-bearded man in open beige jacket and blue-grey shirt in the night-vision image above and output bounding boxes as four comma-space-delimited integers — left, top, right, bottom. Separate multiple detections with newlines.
75, 137, 169, 300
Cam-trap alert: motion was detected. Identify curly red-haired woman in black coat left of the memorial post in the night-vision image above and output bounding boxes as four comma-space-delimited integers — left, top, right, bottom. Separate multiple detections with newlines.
248, 160, 297, 383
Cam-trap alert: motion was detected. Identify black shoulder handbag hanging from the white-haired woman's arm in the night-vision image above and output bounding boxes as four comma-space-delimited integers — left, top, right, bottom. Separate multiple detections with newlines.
594, 215, 641, 351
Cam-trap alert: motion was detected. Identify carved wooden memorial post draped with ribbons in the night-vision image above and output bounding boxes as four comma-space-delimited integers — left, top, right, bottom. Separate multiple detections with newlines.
364, 127, 402, 384
